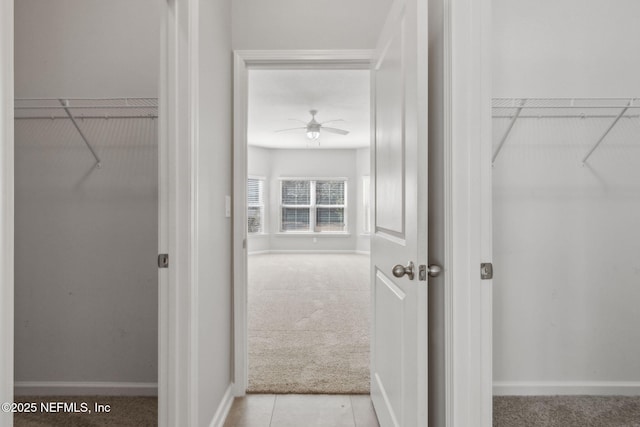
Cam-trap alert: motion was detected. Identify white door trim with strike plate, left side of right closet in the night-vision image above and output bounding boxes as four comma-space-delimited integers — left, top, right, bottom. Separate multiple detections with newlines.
444, 0, 493, 427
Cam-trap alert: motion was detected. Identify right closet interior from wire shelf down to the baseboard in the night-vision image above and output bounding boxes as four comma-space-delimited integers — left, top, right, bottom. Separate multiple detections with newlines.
492, 98, 640, 395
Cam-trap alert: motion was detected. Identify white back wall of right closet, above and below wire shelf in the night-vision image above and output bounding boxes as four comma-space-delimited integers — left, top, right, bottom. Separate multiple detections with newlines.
493, 0, 640, 394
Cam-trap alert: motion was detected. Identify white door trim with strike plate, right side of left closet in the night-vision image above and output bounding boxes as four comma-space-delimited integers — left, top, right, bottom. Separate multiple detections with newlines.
158, 0, 199, 427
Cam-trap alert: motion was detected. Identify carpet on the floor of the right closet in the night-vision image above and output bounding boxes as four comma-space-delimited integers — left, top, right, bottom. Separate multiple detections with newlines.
493, 396, 640, 427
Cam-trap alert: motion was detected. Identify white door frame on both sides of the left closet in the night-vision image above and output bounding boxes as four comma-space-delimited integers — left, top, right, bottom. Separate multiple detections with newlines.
0, 0, 198, 427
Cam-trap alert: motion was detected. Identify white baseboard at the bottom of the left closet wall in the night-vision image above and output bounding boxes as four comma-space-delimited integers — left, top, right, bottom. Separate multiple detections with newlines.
14, 381, 158, 396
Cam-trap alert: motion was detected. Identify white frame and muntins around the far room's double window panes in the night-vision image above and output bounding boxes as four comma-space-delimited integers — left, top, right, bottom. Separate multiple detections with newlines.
278, 177, 350, 236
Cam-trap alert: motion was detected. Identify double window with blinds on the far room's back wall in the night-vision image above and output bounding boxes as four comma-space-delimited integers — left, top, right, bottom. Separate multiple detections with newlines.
280, 179, 347, 233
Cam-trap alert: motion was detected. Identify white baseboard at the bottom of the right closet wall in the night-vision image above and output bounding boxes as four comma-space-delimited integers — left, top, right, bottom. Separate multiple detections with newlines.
493, 381, 640, 396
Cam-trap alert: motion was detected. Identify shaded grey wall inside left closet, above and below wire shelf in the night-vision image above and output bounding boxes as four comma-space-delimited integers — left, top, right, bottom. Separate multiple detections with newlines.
15, 0, 160, 392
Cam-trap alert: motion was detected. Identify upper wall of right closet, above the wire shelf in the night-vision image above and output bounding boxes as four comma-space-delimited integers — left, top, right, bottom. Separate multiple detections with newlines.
492, 0, 640, 97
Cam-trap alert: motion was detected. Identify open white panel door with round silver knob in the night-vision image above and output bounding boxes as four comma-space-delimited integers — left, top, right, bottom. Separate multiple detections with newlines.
371, 0, 428, 427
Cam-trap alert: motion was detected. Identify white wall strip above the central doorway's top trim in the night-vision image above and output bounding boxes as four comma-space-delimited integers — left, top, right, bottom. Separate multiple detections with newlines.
233, 0, 392, 49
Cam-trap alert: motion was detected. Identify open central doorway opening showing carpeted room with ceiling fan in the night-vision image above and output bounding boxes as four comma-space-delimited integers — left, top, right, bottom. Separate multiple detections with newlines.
246, 69, 371, 394
